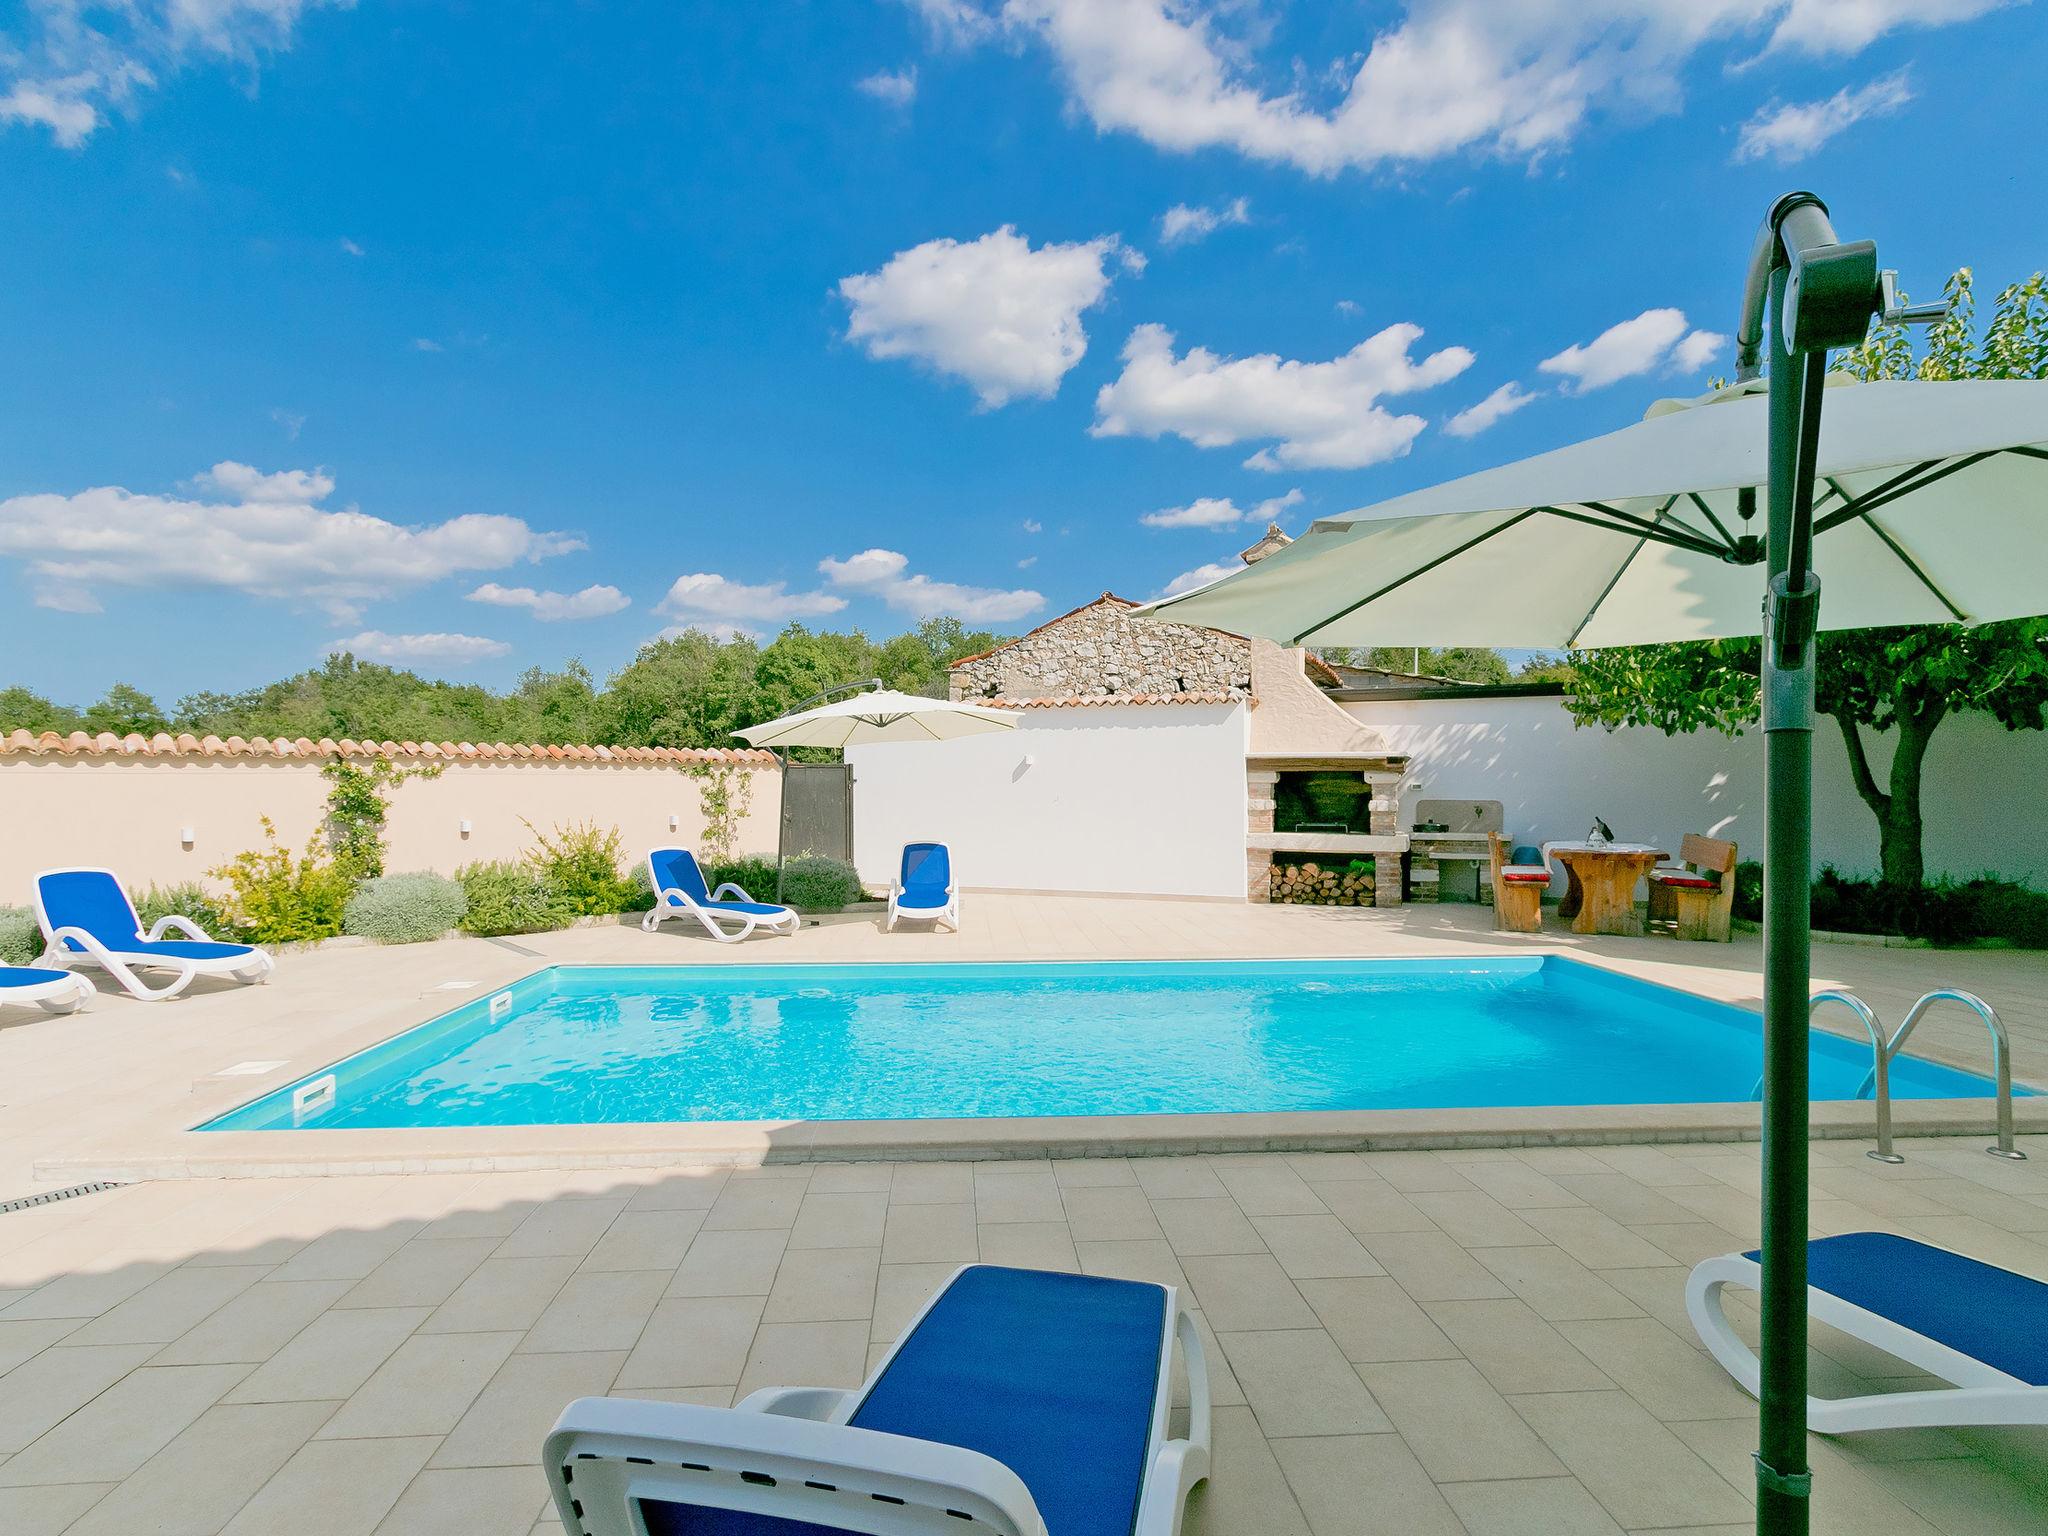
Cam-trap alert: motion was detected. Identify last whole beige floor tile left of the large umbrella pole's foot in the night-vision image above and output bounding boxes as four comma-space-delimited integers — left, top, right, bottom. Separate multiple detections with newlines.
1513, 1393, 1749, 1526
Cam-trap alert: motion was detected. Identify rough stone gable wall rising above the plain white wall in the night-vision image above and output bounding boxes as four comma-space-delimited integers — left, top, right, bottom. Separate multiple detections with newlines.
952, 596, 1251, 698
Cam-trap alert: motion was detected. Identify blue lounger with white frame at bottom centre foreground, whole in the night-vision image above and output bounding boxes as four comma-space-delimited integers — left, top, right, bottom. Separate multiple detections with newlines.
541, 1264, 1208, 1536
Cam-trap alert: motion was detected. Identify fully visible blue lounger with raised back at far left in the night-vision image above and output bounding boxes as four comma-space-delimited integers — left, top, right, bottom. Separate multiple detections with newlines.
35, 868, 274, 1001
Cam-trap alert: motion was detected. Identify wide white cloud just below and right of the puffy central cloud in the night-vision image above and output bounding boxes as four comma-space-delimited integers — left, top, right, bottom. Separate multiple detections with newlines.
1090, 324, 1473, 469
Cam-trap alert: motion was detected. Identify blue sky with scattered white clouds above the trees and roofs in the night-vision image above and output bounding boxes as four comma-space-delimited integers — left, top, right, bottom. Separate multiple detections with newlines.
0, 0, 2048, 702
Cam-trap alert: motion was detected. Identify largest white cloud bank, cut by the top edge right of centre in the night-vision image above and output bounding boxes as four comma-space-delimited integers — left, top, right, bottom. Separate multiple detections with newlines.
911, 0, 2009, 176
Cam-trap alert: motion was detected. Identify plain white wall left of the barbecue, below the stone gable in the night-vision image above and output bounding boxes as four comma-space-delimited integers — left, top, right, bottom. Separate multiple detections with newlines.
846, 702, 1247, 901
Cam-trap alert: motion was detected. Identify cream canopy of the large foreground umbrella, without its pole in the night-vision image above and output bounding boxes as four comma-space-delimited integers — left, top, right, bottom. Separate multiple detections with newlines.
1143, 375, 2048, 649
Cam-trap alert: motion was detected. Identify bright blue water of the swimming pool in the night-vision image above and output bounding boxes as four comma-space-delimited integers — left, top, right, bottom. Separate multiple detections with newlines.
201, 956, 1991, 1130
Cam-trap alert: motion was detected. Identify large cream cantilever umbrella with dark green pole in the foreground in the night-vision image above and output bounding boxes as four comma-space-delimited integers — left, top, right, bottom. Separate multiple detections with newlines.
1137, 193, 2048, 1536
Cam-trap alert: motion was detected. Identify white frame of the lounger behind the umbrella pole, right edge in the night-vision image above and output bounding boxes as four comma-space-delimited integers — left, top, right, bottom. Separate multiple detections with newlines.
1686, 1253, 2048, 1436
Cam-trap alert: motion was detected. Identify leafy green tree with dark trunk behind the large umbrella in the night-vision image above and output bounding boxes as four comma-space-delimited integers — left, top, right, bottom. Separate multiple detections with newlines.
1569, 268, 2048, 889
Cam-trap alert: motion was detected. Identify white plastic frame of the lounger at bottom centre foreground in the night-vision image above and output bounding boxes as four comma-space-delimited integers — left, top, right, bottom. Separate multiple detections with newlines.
541, 1266, 1208, 1536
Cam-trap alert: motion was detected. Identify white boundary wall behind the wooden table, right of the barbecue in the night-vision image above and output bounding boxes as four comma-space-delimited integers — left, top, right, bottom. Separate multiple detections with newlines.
1346, 698, 2048, 885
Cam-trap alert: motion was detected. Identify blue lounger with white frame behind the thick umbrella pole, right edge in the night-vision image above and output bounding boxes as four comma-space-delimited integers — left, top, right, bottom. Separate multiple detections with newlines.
1686, 1233, 2048, 1436
